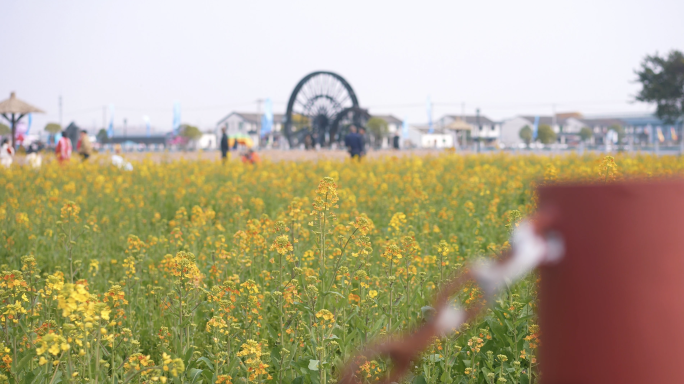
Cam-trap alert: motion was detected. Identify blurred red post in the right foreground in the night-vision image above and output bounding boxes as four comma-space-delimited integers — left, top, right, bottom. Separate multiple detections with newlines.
539, 181, 684, 384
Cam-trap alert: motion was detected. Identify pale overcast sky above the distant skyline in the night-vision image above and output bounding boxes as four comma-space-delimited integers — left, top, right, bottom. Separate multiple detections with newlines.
0, 0, 684, 132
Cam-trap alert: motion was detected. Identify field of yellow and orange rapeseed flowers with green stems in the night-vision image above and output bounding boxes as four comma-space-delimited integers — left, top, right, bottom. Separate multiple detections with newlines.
0, 154, 684, 384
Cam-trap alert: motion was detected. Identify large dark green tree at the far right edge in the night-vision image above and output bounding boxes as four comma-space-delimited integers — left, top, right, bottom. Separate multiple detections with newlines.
634, 50, 684, 124
